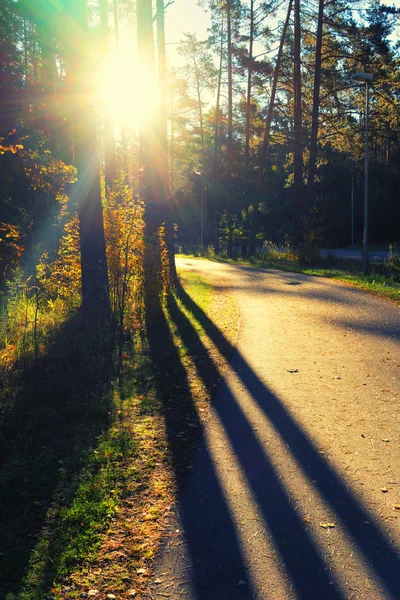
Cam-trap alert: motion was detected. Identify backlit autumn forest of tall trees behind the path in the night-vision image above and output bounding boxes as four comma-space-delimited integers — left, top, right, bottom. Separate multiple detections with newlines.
0, 0, 400, 309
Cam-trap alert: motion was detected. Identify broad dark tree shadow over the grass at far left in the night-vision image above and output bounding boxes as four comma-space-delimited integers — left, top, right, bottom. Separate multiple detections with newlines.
0, 312, 112, 597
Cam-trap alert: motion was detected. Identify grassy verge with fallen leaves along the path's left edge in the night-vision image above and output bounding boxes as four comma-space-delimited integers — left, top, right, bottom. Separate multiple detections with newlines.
0, 272, 238, 600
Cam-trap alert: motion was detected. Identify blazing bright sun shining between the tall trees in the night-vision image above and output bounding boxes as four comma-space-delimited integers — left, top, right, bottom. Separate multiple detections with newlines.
100, 48, 159, 130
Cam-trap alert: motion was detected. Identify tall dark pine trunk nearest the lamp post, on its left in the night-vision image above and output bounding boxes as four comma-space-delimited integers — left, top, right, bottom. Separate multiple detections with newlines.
306, 0, 324, 207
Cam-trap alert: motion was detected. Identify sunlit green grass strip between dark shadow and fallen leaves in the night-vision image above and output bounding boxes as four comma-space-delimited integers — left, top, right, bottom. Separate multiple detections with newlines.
18, 421, 135, 600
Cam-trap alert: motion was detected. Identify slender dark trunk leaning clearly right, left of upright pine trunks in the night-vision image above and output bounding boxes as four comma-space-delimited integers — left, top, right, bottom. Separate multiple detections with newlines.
250, 0, 293, 255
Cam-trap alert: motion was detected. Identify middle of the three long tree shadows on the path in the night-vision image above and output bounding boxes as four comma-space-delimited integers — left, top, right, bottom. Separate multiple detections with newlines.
169, 298, 344, 600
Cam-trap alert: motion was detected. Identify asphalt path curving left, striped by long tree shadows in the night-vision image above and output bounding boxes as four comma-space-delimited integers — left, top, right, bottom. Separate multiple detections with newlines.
145, 259, 400, 600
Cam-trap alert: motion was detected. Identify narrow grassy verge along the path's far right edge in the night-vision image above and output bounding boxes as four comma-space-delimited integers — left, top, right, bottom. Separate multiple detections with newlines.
176, 250, 400, 305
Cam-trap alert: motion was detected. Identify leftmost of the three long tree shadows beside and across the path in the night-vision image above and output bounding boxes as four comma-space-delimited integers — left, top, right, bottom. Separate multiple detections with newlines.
145, 256, 253, 600
